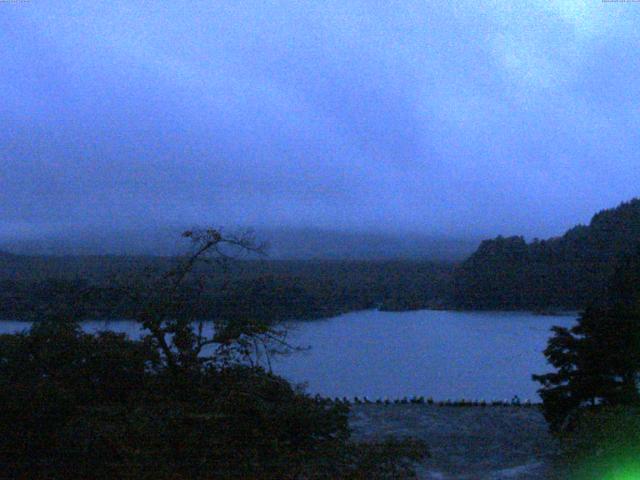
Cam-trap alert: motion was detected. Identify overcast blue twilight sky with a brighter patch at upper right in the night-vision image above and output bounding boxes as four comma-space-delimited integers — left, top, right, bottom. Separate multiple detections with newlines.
0, 0, 640, 244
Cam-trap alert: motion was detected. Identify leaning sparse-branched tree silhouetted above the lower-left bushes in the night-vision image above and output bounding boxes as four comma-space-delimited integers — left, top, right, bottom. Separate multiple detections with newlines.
120, 229, 293, 370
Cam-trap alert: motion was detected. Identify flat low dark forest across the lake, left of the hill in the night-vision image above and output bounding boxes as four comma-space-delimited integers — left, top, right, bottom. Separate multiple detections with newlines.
0, 256, 451, 321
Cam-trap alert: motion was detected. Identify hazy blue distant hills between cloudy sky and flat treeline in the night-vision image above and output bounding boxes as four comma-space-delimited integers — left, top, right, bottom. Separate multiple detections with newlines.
0, 227, 479, 261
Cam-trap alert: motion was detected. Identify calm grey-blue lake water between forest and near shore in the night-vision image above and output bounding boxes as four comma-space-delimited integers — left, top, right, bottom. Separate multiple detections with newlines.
0, 310, 576, 401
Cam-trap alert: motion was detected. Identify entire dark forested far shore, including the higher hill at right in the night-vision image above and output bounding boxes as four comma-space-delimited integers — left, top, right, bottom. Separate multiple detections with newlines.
0, 199, 640, 320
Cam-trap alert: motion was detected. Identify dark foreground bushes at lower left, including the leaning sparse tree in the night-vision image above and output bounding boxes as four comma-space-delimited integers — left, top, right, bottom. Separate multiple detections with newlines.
0, 231, 426, 480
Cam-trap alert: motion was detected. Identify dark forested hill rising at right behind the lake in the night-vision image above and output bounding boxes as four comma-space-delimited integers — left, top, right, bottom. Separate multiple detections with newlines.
452, 198, 640, 310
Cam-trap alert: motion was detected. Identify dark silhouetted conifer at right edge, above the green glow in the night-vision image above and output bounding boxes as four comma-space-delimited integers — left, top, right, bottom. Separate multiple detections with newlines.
533, 256, 640, 430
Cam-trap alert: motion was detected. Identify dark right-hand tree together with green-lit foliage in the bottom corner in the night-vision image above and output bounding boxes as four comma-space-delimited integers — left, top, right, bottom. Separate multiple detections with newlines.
533, 251, 640, 480
